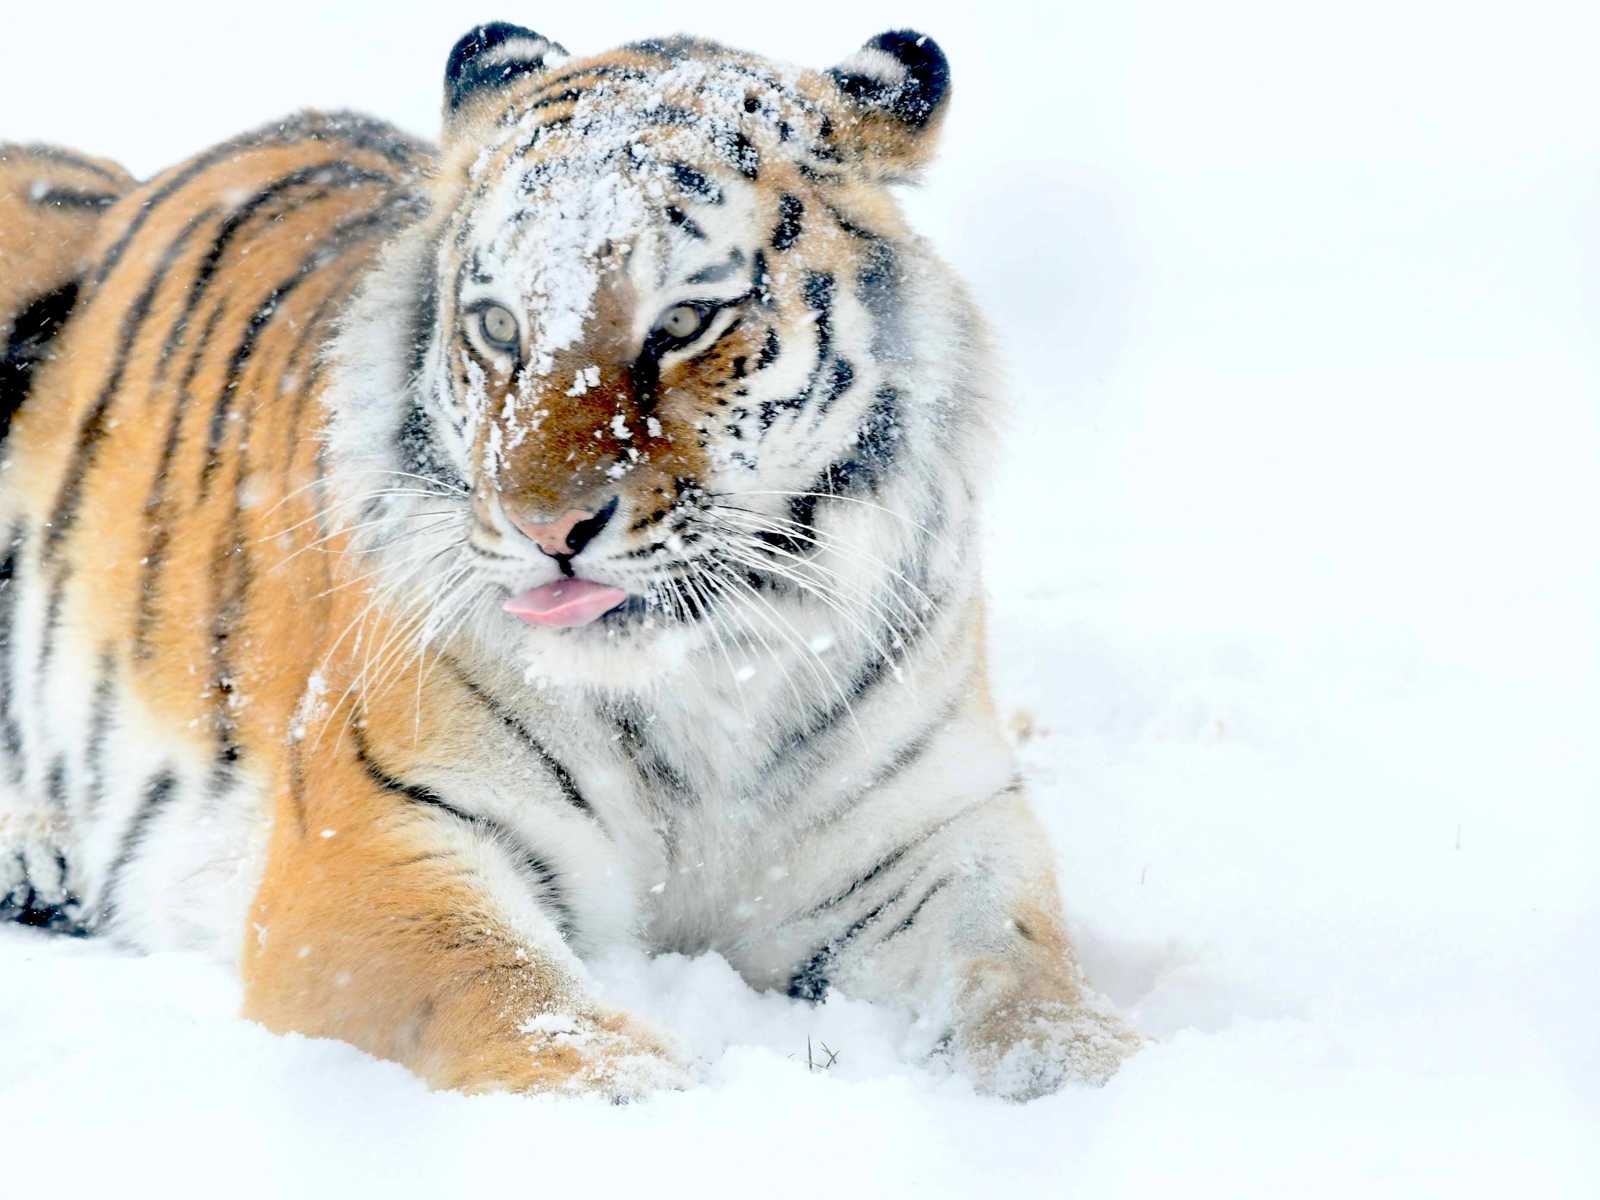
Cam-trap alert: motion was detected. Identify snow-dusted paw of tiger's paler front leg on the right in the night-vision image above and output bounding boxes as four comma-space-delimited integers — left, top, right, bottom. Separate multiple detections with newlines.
955, 997, 1144, 1101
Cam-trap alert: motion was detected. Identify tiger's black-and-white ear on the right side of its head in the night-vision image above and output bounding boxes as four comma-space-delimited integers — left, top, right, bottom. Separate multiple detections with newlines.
827, 29, 950, 178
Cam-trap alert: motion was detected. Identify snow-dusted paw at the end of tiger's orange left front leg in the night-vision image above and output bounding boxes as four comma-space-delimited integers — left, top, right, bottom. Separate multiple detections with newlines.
522, 1011, 691, 1104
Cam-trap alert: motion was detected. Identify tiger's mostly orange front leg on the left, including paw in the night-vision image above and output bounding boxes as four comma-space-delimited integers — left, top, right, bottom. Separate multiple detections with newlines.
242, 742, 682, 1099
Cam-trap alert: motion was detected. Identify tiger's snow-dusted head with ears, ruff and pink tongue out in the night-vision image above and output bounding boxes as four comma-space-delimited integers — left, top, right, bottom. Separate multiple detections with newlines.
328, 24, 987, 686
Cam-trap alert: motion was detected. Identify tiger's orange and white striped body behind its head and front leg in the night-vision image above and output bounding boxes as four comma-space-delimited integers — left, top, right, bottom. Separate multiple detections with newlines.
0, 114, 430, 947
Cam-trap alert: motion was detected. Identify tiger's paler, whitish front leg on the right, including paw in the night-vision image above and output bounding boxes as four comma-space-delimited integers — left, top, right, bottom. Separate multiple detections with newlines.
789, 786, 1142, 1099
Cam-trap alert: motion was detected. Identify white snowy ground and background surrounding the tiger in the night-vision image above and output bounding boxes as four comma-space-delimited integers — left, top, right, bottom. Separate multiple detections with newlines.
0, 0, 1600, 1197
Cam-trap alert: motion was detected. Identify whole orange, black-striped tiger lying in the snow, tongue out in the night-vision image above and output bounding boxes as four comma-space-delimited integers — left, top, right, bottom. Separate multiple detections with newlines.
0, 22, 1141, 1101
